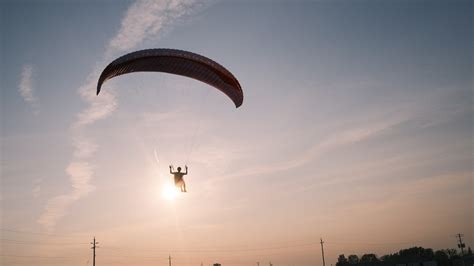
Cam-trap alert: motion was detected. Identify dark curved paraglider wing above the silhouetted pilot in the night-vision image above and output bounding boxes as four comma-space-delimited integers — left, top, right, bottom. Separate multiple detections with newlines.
97, 49, 244, 107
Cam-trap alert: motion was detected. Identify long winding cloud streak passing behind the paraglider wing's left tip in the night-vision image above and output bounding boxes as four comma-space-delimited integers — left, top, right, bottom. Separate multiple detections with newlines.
38, 0, 205, 230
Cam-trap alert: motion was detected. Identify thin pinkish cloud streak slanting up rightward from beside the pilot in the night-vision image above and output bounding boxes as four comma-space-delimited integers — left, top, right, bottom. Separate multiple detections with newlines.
212, 82, 472, 185
